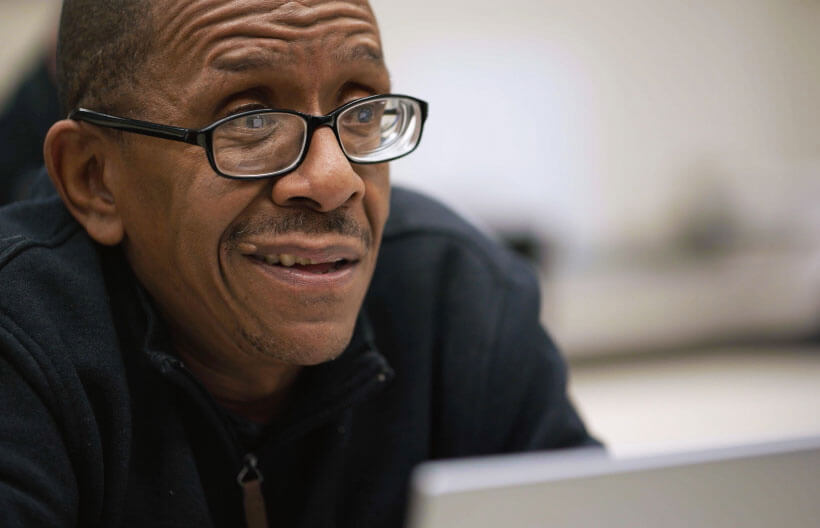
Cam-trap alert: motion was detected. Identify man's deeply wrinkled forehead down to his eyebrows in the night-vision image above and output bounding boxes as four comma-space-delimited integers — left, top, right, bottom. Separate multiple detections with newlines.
140, 0, 387, 113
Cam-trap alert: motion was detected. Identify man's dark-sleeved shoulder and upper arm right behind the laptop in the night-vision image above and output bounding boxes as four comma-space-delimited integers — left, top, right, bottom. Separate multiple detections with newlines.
368, 189, 589, 457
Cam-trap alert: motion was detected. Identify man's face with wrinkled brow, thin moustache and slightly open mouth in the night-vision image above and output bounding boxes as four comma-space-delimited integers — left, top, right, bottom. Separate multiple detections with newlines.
106, 0, 390, 369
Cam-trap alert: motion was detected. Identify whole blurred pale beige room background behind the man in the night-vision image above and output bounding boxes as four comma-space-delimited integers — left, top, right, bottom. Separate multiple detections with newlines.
0, 0, 820, 455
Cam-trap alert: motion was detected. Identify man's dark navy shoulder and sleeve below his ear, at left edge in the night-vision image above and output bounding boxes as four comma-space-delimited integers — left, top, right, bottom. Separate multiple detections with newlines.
0, 197, 130, 526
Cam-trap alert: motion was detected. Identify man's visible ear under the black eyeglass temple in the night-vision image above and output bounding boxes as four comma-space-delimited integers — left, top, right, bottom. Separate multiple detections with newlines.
43, 119, 124, 246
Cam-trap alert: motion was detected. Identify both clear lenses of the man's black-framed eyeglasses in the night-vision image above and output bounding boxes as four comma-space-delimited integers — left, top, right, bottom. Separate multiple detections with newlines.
212, 97, 422, 177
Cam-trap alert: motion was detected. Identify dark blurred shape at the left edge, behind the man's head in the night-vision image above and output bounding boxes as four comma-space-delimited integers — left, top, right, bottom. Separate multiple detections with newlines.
0, 58, 60, 205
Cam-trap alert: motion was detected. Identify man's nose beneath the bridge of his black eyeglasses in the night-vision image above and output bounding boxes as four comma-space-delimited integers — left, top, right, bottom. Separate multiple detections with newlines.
272, 127, 365, 212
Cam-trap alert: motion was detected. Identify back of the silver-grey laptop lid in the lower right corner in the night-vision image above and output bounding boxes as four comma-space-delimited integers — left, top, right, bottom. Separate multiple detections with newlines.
406, 437, 820, 528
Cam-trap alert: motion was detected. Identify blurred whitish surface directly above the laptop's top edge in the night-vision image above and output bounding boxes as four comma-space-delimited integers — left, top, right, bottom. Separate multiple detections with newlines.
570, 345, 820, 456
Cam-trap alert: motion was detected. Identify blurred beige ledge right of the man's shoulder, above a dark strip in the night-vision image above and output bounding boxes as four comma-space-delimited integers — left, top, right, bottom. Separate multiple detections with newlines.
542, 249, 820, 358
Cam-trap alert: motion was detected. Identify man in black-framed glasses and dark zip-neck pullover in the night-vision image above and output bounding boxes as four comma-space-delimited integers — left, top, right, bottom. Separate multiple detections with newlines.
0, 0, 594, 527
